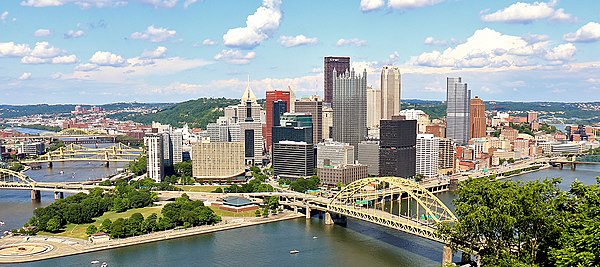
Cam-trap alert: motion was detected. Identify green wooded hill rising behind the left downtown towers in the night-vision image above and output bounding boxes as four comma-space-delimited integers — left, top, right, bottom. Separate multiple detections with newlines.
127, 98, 240, 129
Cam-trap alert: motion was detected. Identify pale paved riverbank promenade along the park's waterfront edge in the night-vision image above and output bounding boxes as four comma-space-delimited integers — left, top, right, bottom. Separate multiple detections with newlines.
0, 212, 304, 264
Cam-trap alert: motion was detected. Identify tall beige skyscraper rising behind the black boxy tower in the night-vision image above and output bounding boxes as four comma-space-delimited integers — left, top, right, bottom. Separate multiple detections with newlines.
381, 66, 402, 120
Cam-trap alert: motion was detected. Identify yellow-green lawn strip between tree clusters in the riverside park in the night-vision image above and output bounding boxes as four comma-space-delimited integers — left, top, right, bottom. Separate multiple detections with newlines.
39, 207, 162, 242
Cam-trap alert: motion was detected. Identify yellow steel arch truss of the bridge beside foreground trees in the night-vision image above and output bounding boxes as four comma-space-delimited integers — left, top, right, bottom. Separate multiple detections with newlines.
327, 177, 457, 243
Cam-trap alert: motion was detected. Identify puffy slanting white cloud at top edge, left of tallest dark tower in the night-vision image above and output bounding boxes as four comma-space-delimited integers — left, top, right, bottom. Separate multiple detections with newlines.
223, 0, 282, 49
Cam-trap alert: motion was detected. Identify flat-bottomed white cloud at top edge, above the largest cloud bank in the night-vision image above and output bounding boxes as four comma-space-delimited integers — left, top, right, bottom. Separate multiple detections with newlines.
481, 1, 573, 24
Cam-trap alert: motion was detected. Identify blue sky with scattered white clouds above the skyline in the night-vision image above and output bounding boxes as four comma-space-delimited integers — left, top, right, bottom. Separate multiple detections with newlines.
0, 0, 600, 104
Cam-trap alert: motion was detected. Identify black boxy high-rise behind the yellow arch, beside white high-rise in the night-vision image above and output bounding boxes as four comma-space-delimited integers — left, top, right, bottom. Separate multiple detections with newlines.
379, 117, 417, 178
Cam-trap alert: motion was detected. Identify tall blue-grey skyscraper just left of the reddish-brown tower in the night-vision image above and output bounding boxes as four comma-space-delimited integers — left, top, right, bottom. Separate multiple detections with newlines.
446, 77, 471, 145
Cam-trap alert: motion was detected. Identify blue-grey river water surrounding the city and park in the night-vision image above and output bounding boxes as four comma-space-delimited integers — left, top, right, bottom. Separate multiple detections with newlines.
0, 163, 600, 266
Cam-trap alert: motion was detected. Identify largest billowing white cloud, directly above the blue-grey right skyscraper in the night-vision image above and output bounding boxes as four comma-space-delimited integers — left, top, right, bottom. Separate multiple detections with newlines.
411, 28, 576, 68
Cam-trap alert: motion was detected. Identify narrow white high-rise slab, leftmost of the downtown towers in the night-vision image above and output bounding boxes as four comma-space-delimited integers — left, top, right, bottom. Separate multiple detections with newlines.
144, 133, 165, 183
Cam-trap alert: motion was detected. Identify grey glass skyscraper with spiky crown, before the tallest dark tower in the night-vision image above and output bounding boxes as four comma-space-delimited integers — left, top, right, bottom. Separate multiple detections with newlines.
332, 69, 367, 158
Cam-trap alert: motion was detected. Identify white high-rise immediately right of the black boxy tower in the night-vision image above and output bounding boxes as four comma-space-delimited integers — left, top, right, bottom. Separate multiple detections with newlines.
416, 134, 440, 178
